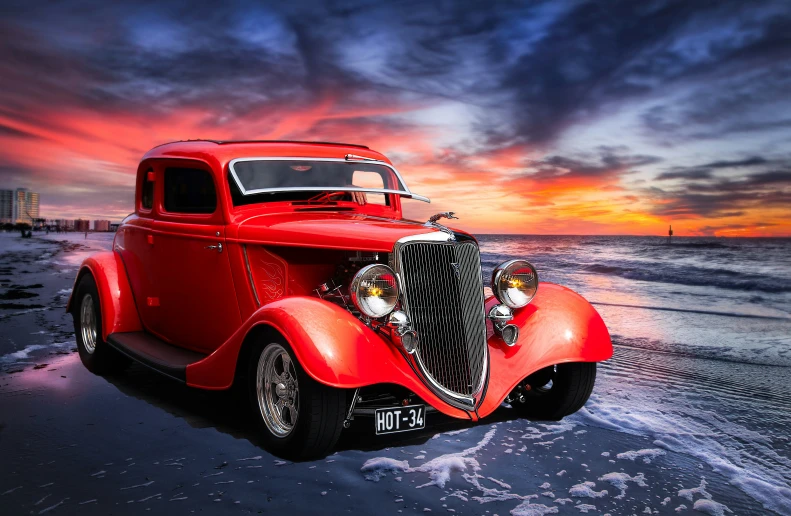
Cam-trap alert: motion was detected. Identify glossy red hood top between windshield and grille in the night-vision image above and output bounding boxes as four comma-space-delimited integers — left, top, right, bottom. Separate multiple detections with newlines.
229, 212, 460, 253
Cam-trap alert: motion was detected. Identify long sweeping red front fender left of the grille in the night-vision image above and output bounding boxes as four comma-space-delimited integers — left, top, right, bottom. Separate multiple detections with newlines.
187, 296, 470, 419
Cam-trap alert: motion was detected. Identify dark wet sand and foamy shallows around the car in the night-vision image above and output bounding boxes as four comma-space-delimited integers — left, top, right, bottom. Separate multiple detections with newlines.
0, 234, 791, 516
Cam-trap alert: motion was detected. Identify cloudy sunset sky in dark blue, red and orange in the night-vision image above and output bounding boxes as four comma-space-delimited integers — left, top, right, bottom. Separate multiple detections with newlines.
0, 0, 791, 236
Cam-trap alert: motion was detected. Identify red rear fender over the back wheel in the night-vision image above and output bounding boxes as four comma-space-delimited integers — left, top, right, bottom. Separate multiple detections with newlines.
66, 251, 143, 339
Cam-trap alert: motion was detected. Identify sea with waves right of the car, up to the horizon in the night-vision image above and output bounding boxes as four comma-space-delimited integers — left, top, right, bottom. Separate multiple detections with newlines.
479, 235, 791, 366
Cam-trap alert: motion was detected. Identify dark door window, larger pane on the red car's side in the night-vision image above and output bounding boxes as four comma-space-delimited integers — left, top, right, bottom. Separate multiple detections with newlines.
164, 168, 217, 213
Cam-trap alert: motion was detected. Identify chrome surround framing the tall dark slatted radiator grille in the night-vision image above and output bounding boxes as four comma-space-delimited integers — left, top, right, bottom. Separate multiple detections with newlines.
390, 236, 489, 410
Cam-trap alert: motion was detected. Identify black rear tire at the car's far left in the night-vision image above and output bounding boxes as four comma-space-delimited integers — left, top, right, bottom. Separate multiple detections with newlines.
71, 273, 131, 375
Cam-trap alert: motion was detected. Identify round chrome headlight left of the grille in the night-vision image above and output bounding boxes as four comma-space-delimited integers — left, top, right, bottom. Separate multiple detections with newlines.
349, 264, 398, 319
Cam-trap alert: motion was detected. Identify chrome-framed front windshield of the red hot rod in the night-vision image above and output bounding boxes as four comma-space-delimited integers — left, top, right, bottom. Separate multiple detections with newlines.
230, 158, 428, 201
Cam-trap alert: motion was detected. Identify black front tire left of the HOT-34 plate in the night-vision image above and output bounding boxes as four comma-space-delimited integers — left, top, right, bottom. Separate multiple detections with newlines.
246, 333, 346, 460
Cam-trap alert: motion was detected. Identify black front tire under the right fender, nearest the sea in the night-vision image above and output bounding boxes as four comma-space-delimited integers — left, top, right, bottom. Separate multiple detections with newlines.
512, 362, 596, 421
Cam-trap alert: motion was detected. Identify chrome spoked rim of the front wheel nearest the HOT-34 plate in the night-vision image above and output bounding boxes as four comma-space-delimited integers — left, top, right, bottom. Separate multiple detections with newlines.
256, 343, 299, 437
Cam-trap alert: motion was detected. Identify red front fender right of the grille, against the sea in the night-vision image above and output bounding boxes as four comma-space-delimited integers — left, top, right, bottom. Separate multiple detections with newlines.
478, 283, 612, 417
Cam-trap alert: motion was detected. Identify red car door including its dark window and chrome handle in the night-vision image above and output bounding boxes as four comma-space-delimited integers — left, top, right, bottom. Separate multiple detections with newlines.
148, 164, 241, 353
